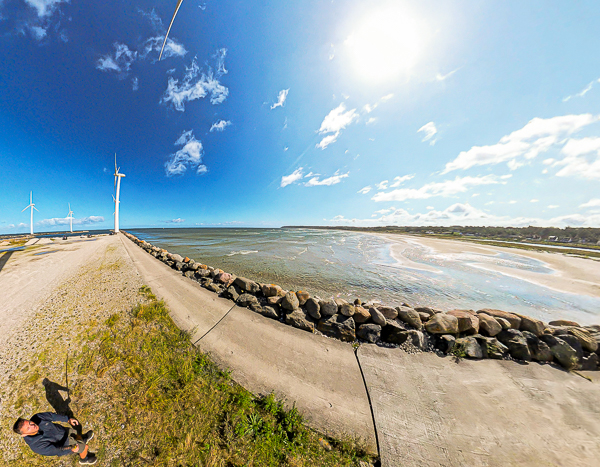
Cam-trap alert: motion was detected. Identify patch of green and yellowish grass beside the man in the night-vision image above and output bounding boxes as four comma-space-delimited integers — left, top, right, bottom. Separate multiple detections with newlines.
15, 287, 369, 467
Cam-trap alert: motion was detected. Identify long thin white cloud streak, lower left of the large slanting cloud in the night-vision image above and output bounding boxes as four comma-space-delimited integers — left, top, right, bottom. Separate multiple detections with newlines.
371, 174, 506, 201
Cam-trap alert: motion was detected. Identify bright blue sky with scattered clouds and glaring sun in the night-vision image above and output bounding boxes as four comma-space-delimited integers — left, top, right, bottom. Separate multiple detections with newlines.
0, 0, 600, 233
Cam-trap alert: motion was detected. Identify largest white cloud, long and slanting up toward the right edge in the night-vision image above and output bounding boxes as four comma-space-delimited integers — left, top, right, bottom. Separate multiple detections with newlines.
442, 114, 600, 173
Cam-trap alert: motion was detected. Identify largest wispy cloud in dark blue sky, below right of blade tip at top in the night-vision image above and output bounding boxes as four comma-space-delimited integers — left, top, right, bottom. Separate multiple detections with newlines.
161, 54, 229, 112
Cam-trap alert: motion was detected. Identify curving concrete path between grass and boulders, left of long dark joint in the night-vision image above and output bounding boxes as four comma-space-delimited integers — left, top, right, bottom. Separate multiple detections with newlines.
119, 235, 377, 453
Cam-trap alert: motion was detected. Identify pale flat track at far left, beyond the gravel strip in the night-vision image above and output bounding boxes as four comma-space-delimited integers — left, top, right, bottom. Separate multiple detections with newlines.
0, 237, 106, 345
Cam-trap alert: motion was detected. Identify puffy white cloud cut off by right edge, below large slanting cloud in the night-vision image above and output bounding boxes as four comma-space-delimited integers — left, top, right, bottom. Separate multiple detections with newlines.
552, 137, 600, 180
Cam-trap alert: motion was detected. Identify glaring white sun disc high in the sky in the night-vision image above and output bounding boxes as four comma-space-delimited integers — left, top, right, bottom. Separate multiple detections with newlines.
345, 8, 427, 82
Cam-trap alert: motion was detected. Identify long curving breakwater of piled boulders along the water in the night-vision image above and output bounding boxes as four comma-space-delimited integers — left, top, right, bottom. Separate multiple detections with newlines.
124, 232, 600, 370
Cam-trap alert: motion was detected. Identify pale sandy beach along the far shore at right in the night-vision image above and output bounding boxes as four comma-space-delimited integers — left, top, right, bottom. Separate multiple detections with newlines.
375, 234, 600, 297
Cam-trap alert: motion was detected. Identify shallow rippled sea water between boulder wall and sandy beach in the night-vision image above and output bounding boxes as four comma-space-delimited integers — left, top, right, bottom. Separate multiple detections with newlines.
129, 229, 600, 324
